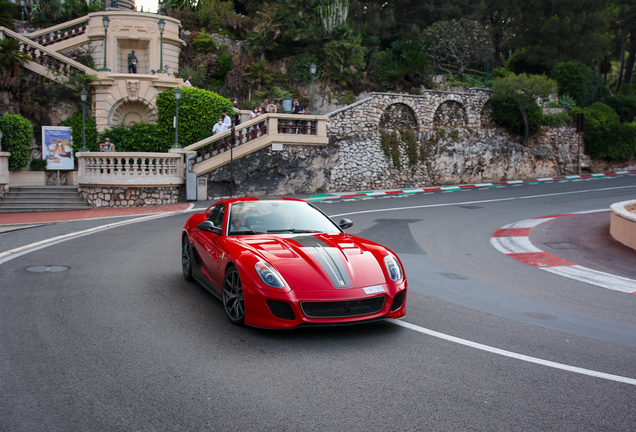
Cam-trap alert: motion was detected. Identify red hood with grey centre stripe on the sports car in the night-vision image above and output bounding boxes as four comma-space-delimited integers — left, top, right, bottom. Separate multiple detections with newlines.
240, 234, 386, 290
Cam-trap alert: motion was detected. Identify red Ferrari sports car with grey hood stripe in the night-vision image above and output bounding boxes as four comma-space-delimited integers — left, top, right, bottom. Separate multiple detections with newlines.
181, 198, 407, 329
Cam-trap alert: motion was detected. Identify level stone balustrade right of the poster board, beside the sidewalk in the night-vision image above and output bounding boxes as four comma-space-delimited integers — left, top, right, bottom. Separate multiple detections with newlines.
77, 152, 185, 186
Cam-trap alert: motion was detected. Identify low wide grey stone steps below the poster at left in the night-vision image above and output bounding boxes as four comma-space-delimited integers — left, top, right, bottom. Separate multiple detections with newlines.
0, 186, 91, 213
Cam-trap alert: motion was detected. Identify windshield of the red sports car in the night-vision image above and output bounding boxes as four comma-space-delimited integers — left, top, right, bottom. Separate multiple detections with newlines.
228, 200, 340, 235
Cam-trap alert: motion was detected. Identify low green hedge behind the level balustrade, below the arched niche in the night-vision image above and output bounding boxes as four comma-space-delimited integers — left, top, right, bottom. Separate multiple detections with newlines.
99, 122, 170, 153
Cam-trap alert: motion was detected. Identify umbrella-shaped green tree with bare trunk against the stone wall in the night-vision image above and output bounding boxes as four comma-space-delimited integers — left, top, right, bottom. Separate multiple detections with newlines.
492, 73, 556, 145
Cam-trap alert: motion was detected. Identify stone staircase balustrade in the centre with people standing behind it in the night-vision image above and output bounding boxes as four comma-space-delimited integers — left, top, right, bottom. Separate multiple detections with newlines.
178, 113, 329, 174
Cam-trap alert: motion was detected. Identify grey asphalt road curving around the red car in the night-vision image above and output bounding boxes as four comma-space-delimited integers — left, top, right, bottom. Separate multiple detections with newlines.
0, 175, 636, 432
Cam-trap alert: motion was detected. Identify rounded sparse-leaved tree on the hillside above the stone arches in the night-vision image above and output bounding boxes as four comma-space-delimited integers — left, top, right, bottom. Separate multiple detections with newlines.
424, 19, 492, 76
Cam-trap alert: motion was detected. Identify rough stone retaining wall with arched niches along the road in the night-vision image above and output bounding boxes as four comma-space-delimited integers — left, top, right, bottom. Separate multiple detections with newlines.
208, 93, 636, 197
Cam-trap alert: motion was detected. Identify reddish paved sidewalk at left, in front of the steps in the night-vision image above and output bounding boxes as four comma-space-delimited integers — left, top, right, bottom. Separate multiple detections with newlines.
0, 203, 192, 226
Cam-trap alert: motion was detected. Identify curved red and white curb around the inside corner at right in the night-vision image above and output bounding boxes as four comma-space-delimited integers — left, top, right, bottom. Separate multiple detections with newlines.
490, 210, 636, 294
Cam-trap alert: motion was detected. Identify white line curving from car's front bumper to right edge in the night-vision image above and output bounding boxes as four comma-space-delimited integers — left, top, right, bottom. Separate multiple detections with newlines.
388, 319, 636, 385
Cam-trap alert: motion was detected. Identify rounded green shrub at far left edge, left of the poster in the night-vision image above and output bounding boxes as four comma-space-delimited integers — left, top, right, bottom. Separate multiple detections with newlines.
0, 114, 33, 171
